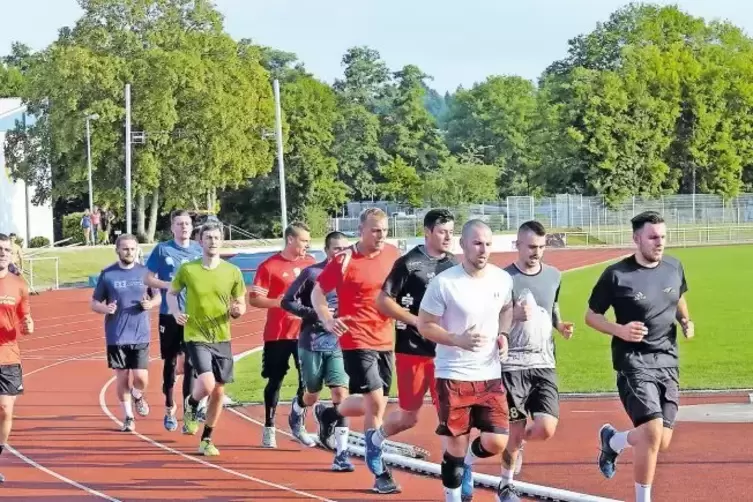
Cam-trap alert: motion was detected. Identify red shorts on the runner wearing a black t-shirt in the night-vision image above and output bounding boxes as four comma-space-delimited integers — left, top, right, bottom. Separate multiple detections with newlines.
395, 353, 437, 411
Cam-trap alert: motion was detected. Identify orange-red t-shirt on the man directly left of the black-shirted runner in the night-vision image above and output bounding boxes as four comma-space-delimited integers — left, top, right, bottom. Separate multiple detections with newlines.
318, 244, 400, 351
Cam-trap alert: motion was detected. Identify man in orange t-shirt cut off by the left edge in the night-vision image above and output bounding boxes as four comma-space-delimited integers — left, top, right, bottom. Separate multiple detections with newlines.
0, 234, 34, 483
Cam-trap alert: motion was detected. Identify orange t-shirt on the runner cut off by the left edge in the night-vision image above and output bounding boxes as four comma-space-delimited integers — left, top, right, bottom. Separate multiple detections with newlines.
0, 273, 31, 366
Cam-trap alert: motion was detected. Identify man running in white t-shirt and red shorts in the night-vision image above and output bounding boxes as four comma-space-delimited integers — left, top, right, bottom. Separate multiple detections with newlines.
418, 220, 520, 502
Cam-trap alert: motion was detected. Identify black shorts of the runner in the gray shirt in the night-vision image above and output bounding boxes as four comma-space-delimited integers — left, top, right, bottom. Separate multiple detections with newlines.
502, 368, 560, 422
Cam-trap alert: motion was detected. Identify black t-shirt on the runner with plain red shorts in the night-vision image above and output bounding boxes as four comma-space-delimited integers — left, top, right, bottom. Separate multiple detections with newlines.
382, 244, 458, 357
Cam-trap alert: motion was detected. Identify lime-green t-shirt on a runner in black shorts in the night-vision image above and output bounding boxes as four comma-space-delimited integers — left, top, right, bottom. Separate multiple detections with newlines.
172, 260, 246, 343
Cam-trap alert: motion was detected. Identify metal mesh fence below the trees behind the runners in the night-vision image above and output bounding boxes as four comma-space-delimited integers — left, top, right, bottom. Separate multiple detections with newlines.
330, 194, 753, 238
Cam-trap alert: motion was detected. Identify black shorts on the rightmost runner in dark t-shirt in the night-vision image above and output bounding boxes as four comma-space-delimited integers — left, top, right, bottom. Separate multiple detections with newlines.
617, 368, 680, 429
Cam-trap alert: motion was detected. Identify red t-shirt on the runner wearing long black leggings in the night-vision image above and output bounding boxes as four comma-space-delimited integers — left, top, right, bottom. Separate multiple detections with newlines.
251, 253, 316, 342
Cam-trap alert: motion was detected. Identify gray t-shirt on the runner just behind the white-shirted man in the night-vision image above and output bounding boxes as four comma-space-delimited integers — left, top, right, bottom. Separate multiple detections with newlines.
502, 263, 562, 371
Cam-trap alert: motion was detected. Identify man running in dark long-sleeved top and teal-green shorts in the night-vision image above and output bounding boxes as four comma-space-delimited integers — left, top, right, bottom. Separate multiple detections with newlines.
281, 232, 354, 472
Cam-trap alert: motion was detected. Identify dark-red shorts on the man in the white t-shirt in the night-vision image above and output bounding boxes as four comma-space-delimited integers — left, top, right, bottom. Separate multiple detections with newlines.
437, 378, 510, 437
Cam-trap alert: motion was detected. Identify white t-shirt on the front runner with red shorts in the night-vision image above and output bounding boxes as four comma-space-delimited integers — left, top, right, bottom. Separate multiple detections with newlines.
421, 264, 512, 382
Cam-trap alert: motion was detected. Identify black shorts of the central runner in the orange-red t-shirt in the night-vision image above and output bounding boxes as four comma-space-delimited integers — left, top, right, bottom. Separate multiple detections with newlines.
343, 349, 394, 396
